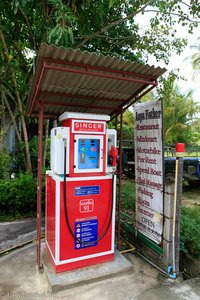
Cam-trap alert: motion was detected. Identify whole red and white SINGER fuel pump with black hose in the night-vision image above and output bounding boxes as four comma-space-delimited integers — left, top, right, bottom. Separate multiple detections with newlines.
46, 112, 118, 273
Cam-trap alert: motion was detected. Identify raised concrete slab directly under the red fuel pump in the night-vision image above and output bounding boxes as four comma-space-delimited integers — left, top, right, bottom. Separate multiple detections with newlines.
42, 247, 133, 292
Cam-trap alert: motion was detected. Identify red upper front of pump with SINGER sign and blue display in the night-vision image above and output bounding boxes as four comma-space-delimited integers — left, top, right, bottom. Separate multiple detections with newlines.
67, 120, 106, 177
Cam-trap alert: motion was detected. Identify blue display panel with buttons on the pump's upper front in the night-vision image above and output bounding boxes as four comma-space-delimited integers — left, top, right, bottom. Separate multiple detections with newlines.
78, 138, 100, 169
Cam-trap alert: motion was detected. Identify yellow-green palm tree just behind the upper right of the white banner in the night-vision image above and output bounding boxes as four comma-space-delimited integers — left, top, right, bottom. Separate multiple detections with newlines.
158, 73, 200, 144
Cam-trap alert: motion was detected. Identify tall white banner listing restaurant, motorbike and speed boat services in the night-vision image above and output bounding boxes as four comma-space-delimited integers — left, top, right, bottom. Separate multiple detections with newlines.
134, 100, 163, 244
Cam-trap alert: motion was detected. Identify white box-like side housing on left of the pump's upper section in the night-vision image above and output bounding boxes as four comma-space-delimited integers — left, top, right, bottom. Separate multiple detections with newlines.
51, 127, 69, 174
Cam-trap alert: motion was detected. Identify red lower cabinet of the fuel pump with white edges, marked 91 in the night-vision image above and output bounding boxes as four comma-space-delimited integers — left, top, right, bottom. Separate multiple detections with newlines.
46, 173, 115, 273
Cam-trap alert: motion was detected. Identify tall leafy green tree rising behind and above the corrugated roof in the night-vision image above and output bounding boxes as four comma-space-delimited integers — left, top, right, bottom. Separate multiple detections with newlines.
0, 0, 200, 172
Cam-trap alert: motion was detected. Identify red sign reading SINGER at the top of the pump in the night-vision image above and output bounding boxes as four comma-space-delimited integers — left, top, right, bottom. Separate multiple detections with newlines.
72, 120, 105, 134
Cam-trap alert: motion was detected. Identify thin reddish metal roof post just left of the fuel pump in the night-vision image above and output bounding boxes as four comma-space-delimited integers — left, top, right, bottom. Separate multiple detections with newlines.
37, 103, 44, 271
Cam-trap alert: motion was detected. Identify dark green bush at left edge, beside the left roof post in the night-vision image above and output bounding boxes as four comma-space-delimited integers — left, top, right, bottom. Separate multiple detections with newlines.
0, 174, 37, 219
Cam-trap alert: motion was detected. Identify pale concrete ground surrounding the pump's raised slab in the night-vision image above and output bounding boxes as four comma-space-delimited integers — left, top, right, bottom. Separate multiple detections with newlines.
0, 243, 200, 300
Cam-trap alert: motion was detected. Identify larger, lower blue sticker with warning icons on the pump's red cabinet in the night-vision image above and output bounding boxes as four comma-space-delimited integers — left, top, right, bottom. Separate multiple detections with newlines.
74, 219, 98, 250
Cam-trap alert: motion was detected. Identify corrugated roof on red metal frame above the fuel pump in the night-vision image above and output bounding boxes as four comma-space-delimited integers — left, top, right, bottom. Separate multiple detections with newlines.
26, 44, 166, 118
